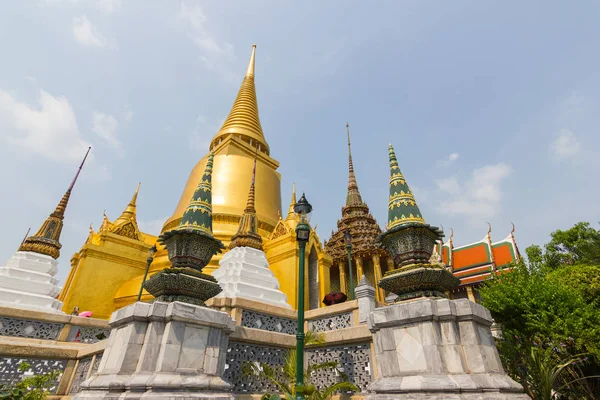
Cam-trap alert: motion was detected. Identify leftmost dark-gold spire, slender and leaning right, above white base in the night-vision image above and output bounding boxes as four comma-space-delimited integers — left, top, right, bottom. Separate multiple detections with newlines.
19, 147, 91, 259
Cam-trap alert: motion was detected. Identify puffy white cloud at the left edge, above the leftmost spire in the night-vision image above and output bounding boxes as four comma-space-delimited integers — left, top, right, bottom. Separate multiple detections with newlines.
0, 90, 89, 162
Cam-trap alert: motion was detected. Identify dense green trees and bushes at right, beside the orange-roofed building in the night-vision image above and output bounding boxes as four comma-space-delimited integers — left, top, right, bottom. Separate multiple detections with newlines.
480, 223, 600, 399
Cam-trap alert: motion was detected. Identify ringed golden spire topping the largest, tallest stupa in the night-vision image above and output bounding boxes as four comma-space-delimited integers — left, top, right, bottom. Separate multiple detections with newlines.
210, 44, 269, 155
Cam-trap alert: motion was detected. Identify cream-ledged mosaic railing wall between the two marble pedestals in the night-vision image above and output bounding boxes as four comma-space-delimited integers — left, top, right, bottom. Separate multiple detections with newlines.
208, 298, 375, 399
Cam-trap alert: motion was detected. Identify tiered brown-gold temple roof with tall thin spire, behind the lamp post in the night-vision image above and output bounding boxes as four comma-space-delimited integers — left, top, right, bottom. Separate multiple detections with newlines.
325, 124, 385, 262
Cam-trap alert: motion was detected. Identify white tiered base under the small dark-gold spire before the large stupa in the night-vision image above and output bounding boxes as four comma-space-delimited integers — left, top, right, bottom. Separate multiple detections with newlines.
213, 247, 292, 309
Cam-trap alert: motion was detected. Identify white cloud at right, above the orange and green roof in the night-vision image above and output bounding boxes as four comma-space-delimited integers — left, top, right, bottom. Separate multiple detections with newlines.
436, 163, 512, 220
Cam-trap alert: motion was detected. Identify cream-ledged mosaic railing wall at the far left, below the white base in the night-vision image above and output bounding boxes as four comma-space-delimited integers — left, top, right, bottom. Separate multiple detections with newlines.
0, 307, 110, 396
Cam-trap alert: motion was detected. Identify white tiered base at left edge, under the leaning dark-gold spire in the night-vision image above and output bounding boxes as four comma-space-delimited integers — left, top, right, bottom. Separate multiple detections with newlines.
0, 251, 63, 314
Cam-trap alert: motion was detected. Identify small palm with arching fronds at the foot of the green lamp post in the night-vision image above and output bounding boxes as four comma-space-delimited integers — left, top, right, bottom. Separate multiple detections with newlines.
243, 331, 360, 400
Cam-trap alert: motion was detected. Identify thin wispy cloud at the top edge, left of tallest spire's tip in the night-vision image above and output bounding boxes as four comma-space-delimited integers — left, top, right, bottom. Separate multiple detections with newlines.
177, 3, 233, 70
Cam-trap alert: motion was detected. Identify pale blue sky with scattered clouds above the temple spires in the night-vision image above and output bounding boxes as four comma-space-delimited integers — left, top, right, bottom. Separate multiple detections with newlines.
0, 0, 600, 280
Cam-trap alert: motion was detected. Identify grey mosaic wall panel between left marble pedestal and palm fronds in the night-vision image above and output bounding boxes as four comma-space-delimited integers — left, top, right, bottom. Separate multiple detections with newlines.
223, 341, 287, 393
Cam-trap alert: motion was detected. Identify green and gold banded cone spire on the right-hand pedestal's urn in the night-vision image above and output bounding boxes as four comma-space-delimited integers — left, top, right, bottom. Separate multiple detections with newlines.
387, 144, 425, 230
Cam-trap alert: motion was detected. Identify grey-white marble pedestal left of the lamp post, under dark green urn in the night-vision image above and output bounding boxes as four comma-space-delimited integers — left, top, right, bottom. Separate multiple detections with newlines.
73, 302, 235, 400
